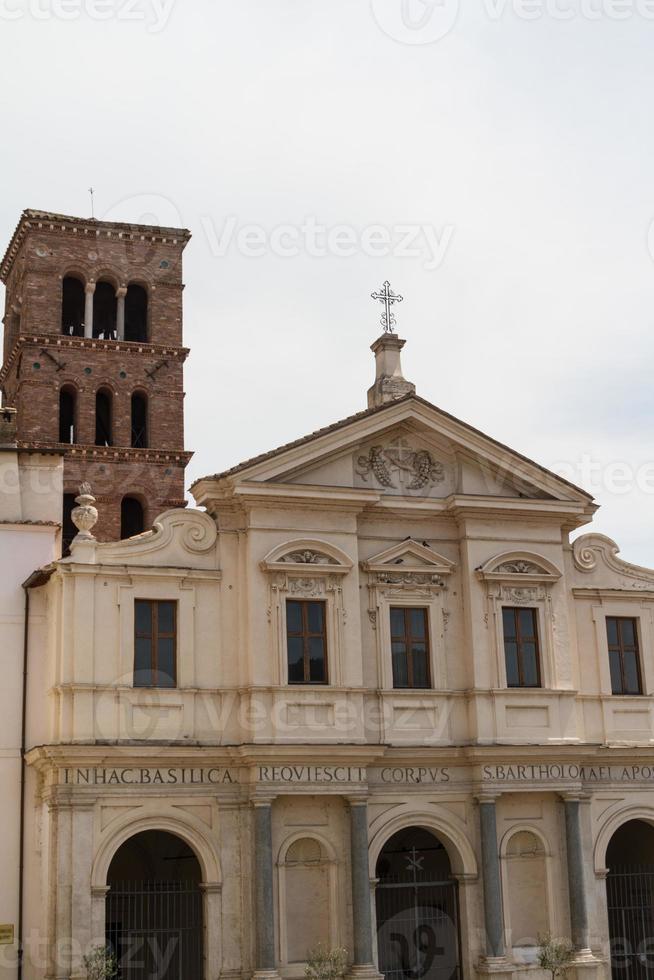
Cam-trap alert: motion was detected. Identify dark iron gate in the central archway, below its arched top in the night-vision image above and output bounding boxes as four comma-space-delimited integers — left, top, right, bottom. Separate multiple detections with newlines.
376, 873, 461, 980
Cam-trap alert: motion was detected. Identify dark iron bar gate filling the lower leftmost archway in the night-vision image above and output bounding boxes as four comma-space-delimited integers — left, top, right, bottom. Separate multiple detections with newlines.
106, 881, 203, 980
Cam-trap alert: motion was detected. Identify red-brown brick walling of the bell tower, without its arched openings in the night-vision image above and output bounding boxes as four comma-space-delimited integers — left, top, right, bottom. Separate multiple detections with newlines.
0, 212, 191, 540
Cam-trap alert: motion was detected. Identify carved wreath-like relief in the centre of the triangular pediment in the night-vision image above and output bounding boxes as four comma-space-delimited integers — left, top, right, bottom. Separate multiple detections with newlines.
354, 435, 447, 496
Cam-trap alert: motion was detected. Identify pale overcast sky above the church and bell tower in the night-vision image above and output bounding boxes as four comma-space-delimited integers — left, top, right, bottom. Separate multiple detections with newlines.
0, 0, 654, 565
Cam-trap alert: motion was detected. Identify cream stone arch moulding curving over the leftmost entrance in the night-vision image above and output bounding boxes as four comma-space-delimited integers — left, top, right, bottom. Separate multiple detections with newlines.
91, 815, 222, 891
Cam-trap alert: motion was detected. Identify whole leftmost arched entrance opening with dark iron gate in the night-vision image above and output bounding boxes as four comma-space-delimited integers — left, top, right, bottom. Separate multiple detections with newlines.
105, 830, 204, 980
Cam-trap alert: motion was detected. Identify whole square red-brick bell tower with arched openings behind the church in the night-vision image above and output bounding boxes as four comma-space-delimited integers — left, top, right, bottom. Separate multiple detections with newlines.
0, 210, 192, 547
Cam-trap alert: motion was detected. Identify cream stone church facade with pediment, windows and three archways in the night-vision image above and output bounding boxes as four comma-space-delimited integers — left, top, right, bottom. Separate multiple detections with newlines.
0, 209, 654, 980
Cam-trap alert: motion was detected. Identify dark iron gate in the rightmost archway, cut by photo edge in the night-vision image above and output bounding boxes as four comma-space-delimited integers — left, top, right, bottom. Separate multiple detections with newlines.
606, 864, 654, 980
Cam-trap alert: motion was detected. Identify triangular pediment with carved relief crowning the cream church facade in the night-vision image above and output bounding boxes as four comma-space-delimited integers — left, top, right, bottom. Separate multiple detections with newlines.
193, 396, 592, 507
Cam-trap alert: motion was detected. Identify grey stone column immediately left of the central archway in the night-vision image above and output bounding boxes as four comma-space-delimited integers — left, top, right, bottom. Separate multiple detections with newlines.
349, 799, 379, 977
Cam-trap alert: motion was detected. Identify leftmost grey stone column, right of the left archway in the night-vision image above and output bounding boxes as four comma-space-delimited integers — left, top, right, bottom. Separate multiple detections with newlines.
254, 800, 278, 977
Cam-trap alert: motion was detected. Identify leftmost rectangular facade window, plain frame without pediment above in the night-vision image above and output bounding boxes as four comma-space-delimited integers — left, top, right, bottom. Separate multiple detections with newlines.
134, 599, 177, 687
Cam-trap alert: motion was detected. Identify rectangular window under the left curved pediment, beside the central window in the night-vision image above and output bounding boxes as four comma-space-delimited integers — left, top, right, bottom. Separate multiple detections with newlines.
286, 599, 327, 684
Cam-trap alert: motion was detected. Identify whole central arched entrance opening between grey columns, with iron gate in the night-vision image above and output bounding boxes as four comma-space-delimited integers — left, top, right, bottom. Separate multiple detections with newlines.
375, 827, 461, 980
